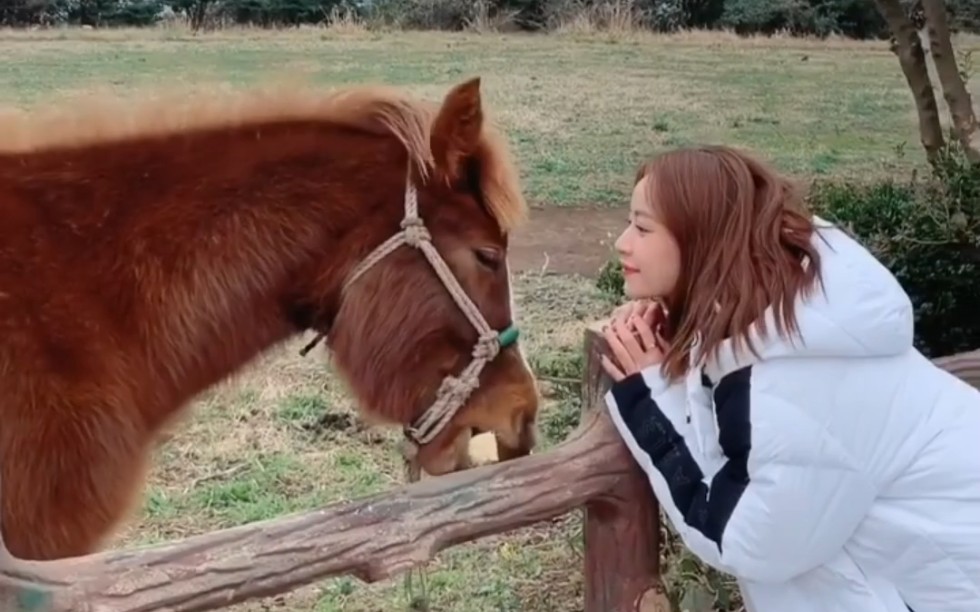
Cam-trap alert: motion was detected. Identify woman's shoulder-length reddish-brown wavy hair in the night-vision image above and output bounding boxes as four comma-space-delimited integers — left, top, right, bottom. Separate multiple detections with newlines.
636, 146, 820, 380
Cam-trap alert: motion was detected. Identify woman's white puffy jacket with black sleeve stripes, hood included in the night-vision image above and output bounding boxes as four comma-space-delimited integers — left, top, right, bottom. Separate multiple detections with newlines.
606, 219, 980, 612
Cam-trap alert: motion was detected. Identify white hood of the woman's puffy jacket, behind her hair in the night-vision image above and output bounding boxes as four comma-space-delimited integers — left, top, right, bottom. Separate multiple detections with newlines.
705, 217, 915, 381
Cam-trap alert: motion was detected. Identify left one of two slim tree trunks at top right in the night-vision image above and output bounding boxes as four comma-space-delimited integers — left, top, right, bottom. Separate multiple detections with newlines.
875, 0, 945, 160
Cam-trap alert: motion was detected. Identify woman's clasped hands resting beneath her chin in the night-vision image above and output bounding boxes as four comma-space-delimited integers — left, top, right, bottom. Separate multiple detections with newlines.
602, 300, 667, 382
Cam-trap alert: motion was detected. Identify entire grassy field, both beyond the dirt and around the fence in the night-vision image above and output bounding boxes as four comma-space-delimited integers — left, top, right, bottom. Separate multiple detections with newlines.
0, 23, 980, 612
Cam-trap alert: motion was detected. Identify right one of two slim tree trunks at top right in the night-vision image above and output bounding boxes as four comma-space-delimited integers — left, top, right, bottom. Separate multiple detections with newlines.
922, 0, 980, 163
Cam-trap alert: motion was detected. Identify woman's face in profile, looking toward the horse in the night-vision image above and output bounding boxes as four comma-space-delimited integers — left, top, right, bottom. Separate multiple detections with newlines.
616, 176, 681, 300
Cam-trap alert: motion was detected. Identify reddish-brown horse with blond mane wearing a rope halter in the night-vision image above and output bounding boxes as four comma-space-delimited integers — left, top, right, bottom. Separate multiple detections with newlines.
0, 79, 538, 559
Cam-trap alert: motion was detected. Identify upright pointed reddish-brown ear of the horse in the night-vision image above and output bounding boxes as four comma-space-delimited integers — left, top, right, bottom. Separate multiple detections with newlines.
431, 77, 483, 182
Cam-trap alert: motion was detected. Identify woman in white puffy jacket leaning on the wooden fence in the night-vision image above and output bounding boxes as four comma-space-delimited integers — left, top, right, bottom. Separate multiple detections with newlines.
604, 147, 980, 612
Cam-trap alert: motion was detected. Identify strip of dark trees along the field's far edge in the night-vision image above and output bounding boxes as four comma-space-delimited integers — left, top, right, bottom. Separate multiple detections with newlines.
0, 0, 980, 38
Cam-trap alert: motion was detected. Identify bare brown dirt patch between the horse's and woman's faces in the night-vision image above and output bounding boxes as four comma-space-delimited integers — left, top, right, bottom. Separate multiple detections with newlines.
510, 206, 626, 278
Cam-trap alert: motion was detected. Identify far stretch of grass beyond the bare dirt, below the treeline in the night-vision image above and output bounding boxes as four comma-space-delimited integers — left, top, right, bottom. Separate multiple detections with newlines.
0, 29, 978, 205
